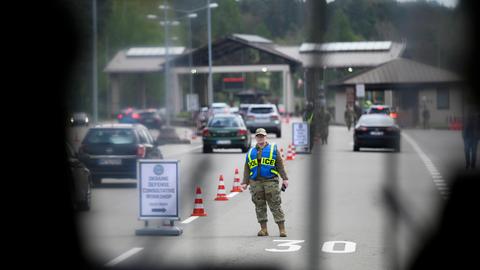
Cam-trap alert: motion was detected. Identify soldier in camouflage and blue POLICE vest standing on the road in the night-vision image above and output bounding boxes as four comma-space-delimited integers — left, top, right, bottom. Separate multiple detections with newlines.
242, 128, 288, 237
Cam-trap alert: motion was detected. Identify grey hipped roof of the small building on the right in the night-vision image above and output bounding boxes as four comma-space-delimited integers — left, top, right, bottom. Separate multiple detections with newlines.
329, 58, 462, 86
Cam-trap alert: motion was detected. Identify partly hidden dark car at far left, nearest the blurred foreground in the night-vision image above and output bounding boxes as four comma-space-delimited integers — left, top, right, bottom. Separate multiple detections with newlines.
66, 143, 92, 211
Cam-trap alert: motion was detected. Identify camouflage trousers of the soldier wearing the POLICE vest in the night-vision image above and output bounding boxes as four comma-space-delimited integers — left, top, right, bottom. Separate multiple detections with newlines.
250, 180, 285, 223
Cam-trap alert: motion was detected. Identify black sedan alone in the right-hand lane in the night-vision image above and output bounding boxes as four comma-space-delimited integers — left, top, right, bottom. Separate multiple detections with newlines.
353, 114, 400, 152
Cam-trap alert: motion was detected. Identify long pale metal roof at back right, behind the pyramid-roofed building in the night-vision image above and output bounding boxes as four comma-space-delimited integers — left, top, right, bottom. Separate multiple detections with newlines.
275, 41, 405, 68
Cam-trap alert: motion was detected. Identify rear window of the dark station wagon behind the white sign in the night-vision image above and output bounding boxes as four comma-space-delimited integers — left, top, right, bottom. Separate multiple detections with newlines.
85, 129, 135, 144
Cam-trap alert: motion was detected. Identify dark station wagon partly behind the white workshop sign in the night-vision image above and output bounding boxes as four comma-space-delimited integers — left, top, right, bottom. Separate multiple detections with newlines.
79, 124, 163, 185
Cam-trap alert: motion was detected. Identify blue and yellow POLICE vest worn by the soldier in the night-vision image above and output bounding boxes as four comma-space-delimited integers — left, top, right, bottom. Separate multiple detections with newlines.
247, 143, 279, 180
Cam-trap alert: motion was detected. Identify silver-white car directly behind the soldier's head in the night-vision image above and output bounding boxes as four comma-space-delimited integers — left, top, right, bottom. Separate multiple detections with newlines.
246, 104, 282, 138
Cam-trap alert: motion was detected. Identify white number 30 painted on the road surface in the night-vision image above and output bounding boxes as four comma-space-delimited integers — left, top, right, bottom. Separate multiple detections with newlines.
265, 240, 357, 253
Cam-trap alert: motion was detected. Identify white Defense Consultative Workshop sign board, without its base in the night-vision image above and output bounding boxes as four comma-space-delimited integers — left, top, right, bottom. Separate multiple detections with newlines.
137, 160, 179, 220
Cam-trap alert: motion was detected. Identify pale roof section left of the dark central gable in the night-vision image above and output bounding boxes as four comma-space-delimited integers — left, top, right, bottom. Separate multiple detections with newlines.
104, 47, 185, 73
